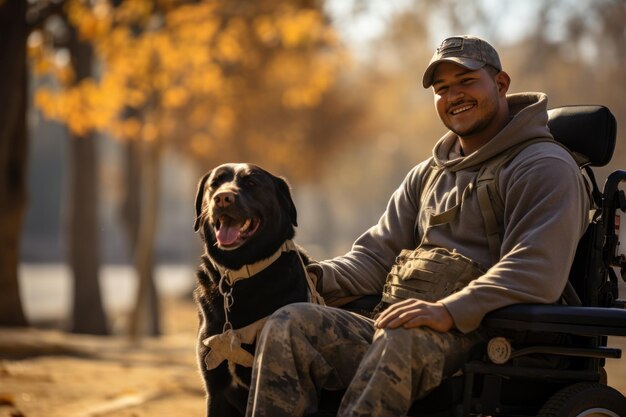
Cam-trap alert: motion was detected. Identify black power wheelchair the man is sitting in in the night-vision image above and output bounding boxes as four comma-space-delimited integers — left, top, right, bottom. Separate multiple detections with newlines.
317, 106, 626, 417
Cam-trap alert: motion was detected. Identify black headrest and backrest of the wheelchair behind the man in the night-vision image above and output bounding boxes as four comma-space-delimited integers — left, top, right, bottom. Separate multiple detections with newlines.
548, 105, 618, 306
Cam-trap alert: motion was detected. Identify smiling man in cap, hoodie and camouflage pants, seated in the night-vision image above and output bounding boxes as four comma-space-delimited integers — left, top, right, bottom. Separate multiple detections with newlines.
247, 36, 589, 417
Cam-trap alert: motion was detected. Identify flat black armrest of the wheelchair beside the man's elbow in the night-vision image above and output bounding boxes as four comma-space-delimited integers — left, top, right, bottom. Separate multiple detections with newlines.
483, 304, 626, 336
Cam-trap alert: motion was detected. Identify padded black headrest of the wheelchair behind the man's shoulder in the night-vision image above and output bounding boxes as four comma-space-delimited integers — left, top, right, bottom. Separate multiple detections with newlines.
548, 105, 617, 167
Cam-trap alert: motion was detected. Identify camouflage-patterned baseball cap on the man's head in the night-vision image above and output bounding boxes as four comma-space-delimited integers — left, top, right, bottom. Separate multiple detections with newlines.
422, 36, 502, 88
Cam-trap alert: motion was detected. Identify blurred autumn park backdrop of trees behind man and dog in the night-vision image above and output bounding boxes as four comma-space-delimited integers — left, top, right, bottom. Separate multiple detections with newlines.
0, 0, 626, 335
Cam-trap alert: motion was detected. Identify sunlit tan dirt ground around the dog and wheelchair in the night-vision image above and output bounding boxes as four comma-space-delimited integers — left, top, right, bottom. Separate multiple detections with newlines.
0, 299, 626, 417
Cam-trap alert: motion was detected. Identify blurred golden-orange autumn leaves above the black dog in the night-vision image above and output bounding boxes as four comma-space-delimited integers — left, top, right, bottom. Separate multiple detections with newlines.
29, 0, 349, 177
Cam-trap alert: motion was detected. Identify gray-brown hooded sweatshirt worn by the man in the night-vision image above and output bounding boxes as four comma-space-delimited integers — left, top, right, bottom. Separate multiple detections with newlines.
314, 93, 589, 333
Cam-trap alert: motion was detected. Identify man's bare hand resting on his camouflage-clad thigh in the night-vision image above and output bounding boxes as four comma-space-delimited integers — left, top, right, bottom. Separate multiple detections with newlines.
376, 298, 454, 333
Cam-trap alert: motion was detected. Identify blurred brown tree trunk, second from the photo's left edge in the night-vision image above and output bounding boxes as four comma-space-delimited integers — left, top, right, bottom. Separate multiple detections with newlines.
68, 26, 108, 334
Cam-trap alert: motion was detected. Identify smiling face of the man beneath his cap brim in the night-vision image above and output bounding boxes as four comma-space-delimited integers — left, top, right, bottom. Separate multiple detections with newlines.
433, 62, 506, 139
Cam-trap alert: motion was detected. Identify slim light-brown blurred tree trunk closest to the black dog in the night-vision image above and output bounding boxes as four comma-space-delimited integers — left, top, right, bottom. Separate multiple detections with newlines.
129, 141, 161, 340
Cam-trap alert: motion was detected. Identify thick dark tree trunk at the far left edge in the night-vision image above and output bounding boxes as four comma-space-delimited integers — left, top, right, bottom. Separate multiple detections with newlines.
0, 0, 28, 326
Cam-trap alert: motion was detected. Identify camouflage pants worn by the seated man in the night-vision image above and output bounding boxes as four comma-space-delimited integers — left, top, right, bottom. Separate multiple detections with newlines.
246, 303, 484, 417
